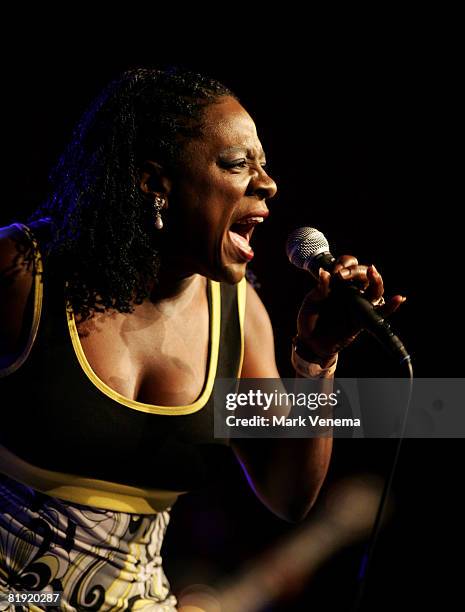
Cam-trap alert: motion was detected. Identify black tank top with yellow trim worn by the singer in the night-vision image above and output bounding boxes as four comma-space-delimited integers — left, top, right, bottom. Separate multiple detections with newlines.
0, 222, 245, 513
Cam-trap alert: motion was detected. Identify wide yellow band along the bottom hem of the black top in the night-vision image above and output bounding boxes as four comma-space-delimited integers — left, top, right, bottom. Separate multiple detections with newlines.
0, 446, 187, 514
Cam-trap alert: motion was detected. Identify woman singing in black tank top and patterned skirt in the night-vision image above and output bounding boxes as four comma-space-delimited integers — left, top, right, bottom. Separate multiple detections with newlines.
0, 68, 402, 611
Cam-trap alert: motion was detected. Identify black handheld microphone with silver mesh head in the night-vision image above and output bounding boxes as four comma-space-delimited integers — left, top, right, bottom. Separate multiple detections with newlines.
286, 227, 410, 363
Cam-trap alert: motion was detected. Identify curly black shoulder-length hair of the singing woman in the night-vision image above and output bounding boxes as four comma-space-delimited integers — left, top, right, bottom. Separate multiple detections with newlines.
29, 68, 237, 320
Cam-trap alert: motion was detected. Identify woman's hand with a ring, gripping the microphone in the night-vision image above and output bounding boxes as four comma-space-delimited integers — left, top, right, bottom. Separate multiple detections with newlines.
297, 255, 405, 362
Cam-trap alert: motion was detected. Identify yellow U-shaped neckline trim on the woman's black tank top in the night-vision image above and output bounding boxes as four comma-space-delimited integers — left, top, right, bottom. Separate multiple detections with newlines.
66, 279, 221, 416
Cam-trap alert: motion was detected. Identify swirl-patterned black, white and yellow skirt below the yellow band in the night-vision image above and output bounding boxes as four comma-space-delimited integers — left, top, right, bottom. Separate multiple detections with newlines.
0, 474, 176, 612
